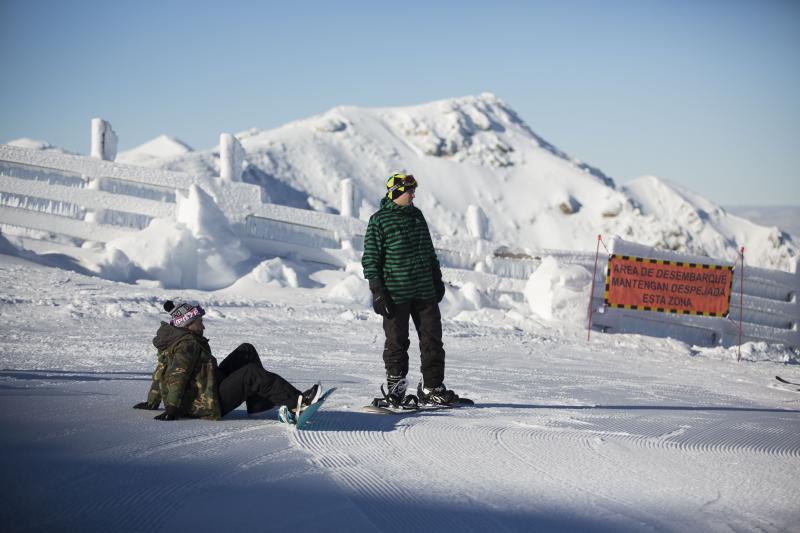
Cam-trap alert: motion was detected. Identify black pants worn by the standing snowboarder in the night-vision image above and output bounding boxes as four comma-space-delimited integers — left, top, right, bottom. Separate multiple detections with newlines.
383, 299, 444, 388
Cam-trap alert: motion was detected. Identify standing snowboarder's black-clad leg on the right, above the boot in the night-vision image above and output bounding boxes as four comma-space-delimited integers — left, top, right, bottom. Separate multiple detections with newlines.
411, 300, 444, 389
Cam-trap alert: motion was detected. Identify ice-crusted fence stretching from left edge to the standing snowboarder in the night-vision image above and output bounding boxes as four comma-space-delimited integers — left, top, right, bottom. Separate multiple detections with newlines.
0, 145, 366, 266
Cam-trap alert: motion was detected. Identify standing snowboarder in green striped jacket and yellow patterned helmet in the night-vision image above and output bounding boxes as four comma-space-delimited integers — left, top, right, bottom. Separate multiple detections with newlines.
361, 174, 459, 407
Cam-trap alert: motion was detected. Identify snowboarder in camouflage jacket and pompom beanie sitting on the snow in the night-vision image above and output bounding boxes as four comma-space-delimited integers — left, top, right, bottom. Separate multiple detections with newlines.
133, 300, 322, 420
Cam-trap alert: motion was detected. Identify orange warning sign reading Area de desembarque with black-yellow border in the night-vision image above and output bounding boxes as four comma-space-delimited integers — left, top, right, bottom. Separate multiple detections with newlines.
605, 255, 733, 316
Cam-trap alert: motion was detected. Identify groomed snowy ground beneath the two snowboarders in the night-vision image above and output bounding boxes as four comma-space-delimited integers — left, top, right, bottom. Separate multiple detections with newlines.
0, 255, 800, 532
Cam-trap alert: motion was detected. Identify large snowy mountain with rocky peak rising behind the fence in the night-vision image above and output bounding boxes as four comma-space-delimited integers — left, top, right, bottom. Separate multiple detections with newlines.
125, 93, 798, 270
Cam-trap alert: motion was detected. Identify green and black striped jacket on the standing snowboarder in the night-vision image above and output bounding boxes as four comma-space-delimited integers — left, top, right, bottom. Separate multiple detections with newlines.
361, 198, 439, 304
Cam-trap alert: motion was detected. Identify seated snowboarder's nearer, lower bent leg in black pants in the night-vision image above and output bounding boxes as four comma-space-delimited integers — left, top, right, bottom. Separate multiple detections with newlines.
218, 363, 302, 416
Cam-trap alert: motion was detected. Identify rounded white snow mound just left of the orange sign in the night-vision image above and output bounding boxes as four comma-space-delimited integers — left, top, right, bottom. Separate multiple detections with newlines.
524, 256, 592, 324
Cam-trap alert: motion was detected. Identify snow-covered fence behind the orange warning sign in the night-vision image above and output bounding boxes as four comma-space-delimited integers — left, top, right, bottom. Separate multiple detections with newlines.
592, 239, 800, 346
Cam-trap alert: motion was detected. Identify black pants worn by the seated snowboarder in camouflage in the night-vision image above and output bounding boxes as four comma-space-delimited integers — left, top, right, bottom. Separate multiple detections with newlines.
216, 343, 301, 416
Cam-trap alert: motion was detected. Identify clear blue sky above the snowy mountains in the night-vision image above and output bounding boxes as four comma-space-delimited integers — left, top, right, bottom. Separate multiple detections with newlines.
0, 0, 800, 205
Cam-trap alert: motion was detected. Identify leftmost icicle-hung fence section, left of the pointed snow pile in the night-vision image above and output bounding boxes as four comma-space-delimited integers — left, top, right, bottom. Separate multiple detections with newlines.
0, 150, 192, 242
